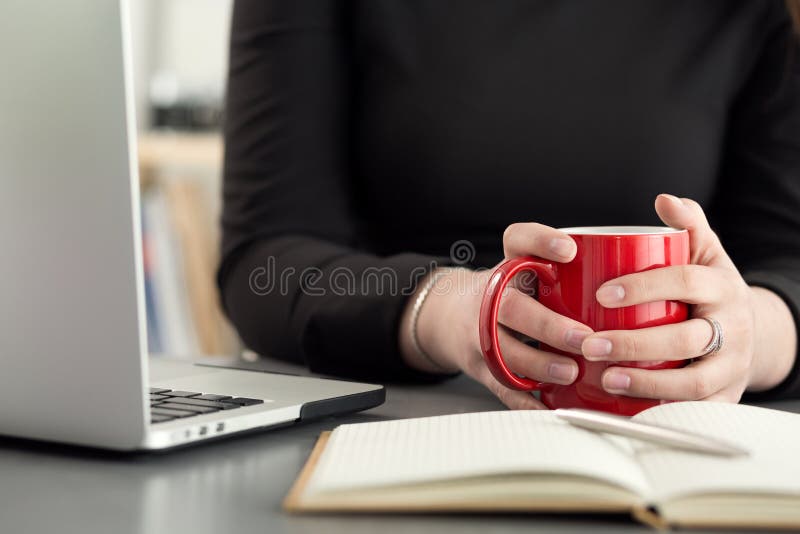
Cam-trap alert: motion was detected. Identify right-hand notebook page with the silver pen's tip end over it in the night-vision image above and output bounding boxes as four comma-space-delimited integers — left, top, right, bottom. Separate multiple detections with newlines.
634, 402, 800, 499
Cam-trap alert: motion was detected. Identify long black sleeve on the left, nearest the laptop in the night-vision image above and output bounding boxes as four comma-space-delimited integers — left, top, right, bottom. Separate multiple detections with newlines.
219, 0, 444, 386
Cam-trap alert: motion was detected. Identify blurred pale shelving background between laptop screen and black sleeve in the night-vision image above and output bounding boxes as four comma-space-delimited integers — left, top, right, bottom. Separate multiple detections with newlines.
131, 0, 241, 356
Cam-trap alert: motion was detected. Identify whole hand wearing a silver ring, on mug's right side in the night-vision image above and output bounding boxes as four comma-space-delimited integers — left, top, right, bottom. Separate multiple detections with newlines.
582, 195, 756, 402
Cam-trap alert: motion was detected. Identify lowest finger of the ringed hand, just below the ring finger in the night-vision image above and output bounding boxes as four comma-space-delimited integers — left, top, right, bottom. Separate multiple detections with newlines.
601, 355, 737, 400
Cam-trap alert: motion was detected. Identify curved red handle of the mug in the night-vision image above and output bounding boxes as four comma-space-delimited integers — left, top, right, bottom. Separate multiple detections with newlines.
478, 256, 556, 391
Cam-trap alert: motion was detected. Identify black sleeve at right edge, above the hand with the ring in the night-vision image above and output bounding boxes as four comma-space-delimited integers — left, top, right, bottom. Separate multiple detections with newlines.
709, 5, 800, 400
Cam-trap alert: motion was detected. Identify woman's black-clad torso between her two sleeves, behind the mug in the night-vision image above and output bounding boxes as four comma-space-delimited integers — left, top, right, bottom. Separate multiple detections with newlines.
350, 0, 769, 265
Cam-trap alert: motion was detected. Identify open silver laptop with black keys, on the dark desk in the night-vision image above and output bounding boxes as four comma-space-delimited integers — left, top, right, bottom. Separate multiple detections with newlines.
0, 0, 385, 451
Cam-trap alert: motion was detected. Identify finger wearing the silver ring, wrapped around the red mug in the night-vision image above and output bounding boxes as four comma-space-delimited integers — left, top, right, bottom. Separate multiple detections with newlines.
581, 319, 714, 362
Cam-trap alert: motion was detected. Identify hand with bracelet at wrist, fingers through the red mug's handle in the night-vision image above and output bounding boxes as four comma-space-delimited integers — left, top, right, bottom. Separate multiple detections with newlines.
400, 223, 592, 409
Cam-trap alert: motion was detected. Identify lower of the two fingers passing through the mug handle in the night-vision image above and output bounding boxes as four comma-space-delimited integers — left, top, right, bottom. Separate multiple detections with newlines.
498, 329, 578, 385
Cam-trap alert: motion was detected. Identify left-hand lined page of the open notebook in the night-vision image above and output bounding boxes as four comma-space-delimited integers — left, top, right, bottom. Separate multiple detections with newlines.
307, 411, 649, 495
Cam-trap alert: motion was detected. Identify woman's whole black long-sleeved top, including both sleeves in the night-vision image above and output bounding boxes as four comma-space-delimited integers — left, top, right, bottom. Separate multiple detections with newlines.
219, 0, 800, 402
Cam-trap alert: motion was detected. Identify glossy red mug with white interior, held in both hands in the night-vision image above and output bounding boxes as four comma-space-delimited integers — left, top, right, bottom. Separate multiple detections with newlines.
479, 226, 689, 415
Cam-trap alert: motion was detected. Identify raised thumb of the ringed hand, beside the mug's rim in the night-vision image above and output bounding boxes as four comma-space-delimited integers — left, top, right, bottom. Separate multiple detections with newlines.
655, 194, 733, 267
